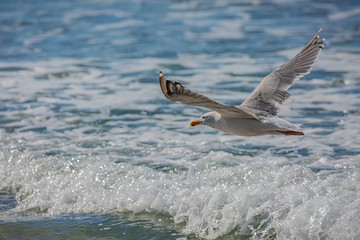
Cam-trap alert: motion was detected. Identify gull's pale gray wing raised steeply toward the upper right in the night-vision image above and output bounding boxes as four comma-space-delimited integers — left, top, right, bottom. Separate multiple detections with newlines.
240, 28, 325, 116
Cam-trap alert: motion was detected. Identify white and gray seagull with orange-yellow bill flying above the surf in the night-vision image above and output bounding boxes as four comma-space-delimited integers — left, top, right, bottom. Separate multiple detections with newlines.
159, 28, 325, 136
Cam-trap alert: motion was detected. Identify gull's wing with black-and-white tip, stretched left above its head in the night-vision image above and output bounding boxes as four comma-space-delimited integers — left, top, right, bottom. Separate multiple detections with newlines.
159, 72, 255, 118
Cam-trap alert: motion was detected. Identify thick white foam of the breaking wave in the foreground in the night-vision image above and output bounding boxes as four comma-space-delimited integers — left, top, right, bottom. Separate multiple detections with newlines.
1, 145, 360, 239
